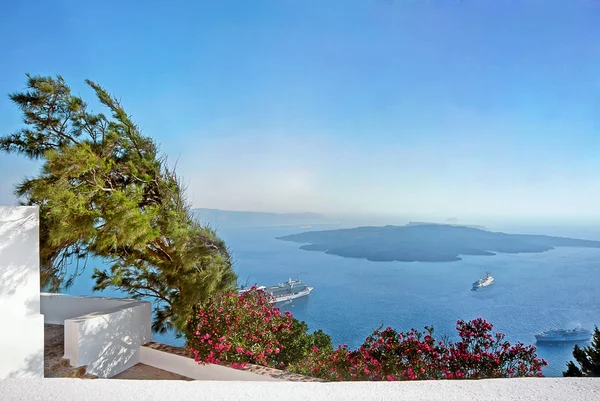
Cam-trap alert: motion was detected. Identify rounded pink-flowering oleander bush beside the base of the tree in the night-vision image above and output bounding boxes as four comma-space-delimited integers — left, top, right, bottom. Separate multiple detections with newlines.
186, 287, 332, 368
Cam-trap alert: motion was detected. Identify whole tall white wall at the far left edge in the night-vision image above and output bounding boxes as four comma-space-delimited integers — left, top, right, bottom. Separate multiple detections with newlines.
0, 206, 44, 379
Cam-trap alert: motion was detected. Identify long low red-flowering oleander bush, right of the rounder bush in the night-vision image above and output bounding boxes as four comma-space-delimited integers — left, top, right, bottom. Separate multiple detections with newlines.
290, 319, 547, 381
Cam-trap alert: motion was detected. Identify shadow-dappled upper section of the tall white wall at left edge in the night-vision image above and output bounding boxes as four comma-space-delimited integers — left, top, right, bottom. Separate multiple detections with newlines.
0, 206, 40, 317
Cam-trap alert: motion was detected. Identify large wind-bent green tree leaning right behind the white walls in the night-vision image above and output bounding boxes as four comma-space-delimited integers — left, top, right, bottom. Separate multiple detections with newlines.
0, 75, 237, 331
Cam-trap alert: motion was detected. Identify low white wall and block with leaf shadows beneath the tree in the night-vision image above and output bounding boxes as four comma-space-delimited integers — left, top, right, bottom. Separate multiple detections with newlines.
41, 293, 152, 378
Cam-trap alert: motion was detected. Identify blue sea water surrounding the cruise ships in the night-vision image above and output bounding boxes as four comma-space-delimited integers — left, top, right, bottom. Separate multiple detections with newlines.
68, 227, 600, 376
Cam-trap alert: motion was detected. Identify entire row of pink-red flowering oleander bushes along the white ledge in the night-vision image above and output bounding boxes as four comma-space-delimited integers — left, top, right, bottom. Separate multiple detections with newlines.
187, 287, 547, 381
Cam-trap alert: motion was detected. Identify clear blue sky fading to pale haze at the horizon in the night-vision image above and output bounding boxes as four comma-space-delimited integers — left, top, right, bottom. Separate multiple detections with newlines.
0, 0, 600, 222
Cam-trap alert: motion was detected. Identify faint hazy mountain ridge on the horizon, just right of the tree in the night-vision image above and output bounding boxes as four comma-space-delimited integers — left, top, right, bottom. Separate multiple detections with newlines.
192, 208, 326, 227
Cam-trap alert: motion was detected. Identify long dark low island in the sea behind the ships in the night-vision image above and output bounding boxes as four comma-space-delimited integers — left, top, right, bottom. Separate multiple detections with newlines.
277, 223, 600, 262
